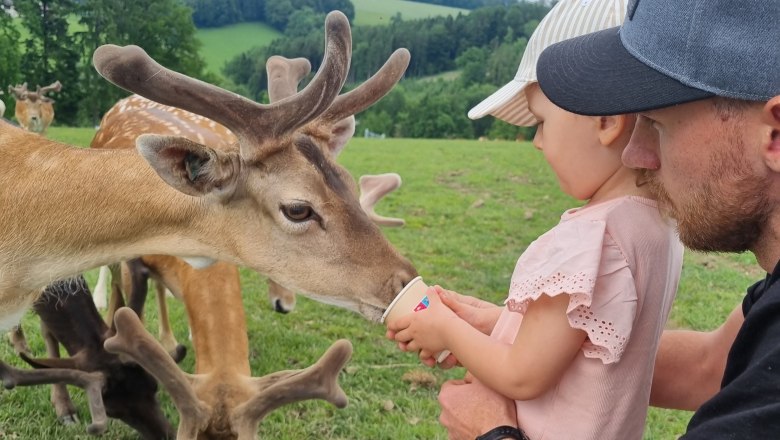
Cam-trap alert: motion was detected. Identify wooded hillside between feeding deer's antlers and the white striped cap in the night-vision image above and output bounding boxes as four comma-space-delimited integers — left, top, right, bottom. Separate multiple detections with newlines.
224, 2, 549, 139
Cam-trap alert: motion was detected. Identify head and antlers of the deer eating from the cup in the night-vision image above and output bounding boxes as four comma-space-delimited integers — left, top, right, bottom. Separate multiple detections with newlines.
93, 12, 416, 320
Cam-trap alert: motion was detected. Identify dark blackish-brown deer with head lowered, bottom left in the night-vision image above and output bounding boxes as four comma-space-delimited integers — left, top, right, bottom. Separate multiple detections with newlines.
0, 276, 175, 440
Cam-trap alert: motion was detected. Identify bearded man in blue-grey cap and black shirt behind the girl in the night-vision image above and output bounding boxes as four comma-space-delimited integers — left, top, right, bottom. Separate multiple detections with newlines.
442, 0, 780, 439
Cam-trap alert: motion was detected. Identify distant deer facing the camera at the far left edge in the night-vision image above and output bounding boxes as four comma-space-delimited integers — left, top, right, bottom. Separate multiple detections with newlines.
8, 81, 62, 134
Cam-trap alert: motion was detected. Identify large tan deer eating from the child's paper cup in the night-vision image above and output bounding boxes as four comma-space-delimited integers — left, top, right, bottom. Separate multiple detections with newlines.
0, 11, 417, 329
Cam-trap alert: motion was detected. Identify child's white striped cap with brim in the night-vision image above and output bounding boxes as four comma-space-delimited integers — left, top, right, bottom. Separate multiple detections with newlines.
469, 0, 628, 127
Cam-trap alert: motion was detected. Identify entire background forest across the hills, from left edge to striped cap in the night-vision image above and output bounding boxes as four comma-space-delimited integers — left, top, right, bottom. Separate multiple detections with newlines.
0, 0, 549, 139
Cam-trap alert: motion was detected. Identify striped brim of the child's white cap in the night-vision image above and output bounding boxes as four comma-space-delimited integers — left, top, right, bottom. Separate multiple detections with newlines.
468, 80, 537, 126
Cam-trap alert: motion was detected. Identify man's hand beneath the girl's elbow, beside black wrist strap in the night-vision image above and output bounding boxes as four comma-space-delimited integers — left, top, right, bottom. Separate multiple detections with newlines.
439, 374, 517, 440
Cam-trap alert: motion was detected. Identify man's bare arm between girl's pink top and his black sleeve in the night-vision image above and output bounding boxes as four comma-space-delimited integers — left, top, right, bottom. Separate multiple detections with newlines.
650, 305, 744, 411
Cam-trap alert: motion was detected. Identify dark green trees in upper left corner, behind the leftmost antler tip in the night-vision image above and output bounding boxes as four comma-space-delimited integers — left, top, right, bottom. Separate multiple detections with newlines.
0, 0, 209, 126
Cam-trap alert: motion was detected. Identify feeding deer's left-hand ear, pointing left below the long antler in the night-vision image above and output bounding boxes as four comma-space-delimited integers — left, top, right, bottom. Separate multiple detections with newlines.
135, 134, 239, 197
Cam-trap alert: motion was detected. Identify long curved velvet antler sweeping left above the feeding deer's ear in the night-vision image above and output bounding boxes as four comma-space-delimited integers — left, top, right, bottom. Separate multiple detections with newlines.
93, 11, 352, 140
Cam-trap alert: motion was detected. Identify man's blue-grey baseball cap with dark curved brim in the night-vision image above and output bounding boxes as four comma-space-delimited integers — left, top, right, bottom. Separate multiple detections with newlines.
536, 0, 780, 115
